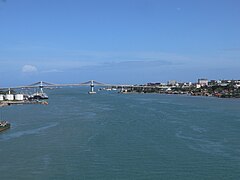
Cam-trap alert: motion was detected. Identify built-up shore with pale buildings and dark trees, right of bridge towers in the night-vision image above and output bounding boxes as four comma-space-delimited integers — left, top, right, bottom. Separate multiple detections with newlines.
120, 80, 240, 98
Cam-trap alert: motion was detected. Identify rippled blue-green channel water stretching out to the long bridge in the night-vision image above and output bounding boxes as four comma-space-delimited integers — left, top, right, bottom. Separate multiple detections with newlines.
0, 88, 240, 180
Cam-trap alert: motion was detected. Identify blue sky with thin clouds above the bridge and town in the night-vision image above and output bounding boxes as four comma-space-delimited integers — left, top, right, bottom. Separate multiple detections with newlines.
0, 0, 240, 87
